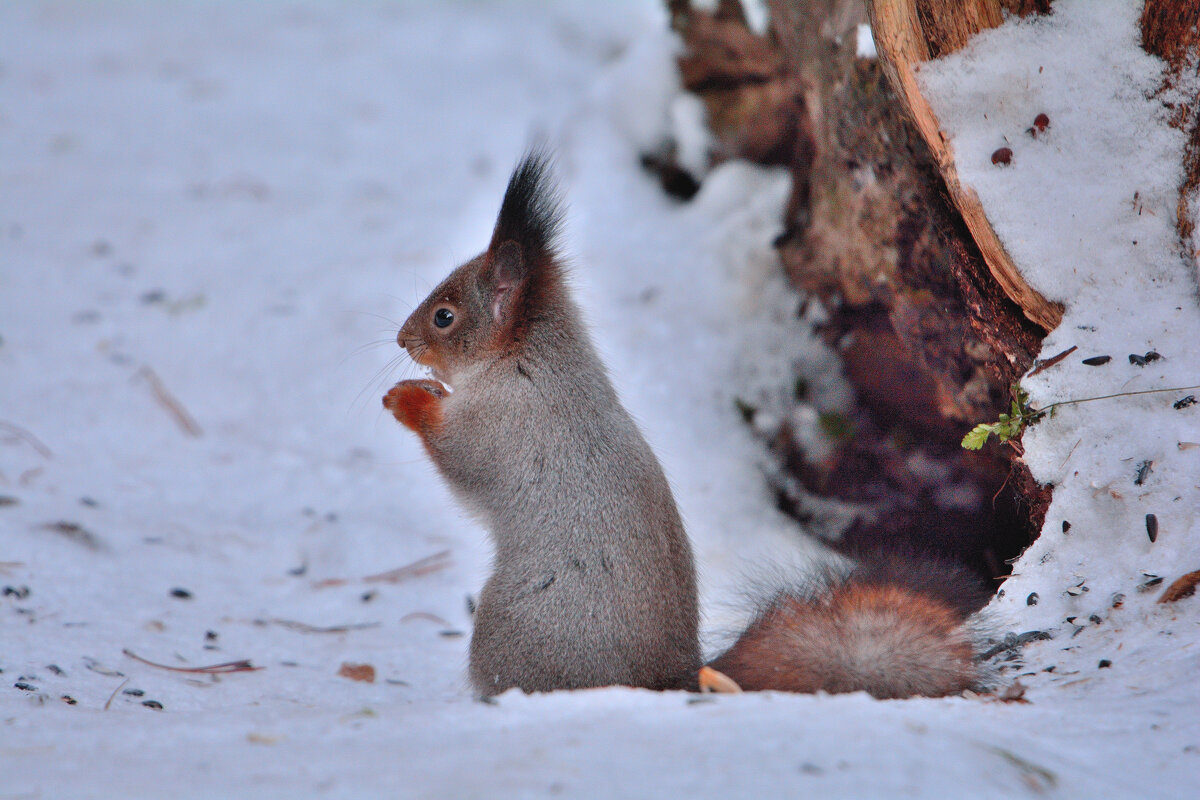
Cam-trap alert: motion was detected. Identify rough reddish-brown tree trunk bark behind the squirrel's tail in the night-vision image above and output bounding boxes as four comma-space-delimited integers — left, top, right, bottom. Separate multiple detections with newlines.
673, 0, 1056, 577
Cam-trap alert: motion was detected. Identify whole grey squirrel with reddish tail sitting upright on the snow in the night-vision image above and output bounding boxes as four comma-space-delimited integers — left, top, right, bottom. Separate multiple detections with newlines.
383, 150, 982, 698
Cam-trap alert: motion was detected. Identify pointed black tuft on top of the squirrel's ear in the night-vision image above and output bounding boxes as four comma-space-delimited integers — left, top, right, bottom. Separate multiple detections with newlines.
487, 146, 563, 264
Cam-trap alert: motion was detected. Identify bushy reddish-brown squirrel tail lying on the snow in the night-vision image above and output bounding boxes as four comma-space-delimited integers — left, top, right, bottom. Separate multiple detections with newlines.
709, 555, 986, 699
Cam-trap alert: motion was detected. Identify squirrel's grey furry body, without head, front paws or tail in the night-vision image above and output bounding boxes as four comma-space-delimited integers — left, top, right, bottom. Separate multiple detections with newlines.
445, 299, 700, 693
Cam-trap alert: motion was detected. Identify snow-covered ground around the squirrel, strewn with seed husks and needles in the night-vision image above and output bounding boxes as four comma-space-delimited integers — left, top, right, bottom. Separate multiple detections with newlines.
0, 0, 1200, 798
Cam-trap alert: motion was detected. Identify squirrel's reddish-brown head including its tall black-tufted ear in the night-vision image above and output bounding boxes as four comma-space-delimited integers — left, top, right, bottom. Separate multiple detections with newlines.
396, 150, 564, 386
